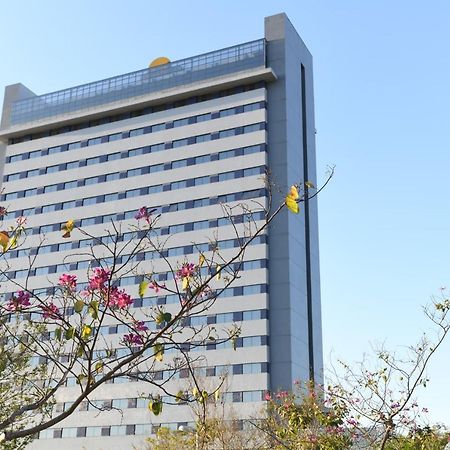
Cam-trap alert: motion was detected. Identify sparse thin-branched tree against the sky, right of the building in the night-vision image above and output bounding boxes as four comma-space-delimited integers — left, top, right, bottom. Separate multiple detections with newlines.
327, 289, 450, 450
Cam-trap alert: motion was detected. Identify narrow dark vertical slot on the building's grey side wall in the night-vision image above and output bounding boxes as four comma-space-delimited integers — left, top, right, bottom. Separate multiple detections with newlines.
301, 64, 314, 381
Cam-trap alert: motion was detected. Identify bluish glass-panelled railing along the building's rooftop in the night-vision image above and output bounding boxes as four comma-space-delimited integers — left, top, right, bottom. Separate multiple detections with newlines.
10, 39, 265, 125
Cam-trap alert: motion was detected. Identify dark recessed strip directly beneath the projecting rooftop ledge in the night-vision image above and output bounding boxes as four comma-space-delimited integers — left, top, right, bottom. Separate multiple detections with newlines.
8, 82, 265, 145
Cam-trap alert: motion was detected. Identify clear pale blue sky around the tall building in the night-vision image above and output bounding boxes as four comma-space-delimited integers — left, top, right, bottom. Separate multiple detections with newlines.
0, 0, 450, 425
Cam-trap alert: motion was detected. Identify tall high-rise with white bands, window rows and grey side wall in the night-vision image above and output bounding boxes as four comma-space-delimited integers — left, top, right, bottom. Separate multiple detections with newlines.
0, 14, 322, 450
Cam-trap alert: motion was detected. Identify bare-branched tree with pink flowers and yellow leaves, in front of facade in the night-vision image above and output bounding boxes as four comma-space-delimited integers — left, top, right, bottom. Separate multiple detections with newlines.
0, 171, 332, 448
